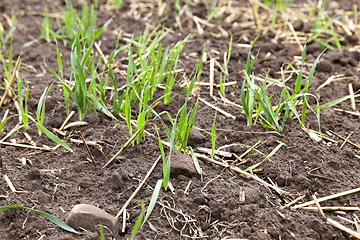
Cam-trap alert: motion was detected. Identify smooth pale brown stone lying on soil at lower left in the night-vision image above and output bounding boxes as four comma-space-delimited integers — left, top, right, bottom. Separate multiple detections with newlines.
65, 204, 118, 233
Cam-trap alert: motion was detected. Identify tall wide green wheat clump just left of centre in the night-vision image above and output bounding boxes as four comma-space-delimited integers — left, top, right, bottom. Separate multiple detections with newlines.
114, 29, 190, 143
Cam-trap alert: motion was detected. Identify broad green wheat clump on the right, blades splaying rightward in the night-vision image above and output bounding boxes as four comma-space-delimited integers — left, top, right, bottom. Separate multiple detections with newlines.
241, 35, 349, 132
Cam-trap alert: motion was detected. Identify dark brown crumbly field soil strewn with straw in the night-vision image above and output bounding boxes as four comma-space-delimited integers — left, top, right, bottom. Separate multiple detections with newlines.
0, 0, 360, 239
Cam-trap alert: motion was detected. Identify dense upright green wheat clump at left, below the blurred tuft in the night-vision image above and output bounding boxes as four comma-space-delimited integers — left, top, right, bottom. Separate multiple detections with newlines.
44, 34, 101, 121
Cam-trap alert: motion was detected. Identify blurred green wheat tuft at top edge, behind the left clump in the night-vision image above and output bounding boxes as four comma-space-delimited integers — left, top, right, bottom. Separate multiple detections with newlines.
57, 0, 113, 46
